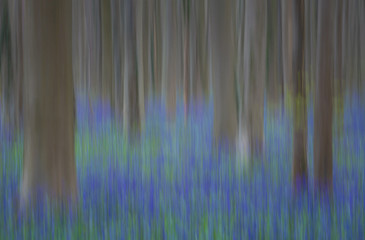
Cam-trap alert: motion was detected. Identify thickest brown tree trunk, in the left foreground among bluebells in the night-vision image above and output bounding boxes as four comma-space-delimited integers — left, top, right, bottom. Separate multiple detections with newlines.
20, 0, 77, 206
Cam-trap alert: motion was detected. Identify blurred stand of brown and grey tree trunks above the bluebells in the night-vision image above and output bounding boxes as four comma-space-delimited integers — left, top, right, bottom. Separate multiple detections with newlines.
0, 0, 365, 238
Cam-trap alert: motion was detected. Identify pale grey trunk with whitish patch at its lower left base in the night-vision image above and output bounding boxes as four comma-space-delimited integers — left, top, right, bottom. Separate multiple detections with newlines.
239, 0, 267, 159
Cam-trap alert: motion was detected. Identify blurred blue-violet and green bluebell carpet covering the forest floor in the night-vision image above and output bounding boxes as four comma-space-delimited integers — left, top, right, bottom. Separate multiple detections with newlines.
0, 94, 365, 239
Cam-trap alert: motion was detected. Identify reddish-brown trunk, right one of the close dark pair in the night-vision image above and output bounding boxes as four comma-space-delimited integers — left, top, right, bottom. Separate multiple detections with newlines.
313, 0, 334, 191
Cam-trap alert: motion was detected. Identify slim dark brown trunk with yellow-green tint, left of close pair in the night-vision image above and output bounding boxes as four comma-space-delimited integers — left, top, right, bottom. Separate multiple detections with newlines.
293, 0, 308, 187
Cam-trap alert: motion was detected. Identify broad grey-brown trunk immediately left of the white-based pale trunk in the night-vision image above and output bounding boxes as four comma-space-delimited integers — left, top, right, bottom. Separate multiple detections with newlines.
209, 0, 237, 146
